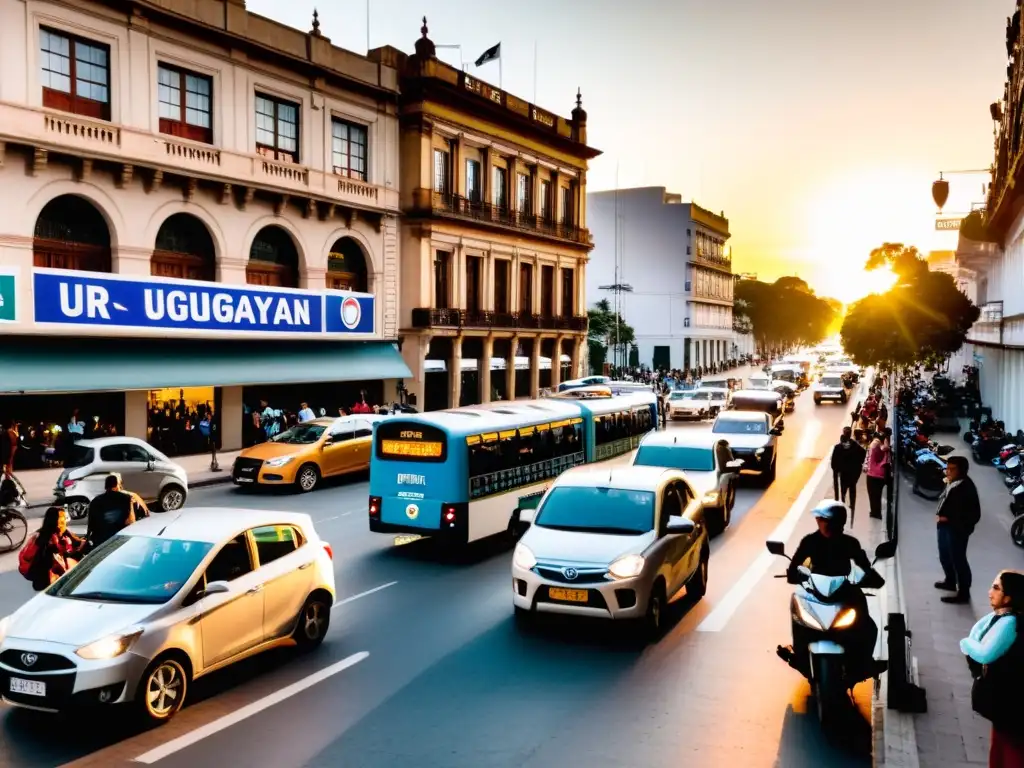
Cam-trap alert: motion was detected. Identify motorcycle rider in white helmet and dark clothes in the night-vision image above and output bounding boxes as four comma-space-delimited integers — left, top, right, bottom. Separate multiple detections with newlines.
786, 499, 879, 669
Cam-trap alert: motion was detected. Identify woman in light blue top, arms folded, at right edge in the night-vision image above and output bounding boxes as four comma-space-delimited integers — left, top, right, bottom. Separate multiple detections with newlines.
961, 570, 1024, 768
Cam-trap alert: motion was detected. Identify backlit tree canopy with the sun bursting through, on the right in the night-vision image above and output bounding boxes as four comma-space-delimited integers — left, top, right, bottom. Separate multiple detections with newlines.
841, 243, 980, 368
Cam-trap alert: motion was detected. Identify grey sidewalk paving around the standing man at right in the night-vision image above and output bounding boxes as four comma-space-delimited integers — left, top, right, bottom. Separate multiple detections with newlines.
899, 448, 1021, 768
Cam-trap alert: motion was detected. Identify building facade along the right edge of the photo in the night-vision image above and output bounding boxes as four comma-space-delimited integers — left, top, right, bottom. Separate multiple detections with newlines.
956, 0, 1024, 432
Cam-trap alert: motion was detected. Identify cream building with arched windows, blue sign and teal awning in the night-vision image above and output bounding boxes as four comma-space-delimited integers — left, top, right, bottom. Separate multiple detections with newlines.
0, 0, 409, 458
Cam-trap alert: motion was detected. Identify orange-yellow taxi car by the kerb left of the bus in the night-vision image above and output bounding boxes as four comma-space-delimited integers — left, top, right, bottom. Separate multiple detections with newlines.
231, 414, 387, 493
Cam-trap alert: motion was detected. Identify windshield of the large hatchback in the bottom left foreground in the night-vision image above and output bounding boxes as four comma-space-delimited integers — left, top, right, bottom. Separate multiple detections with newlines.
46, 536, 213, 605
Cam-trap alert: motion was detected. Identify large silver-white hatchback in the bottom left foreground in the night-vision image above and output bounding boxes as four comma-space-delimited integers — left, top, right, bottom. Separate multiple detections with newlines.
0, 508, 335, 723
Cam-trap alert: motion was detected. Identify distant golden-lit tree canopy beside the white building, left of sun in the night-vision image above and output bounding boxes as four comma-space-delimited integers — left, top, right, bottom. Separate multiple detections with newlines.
733, 275, 837, 352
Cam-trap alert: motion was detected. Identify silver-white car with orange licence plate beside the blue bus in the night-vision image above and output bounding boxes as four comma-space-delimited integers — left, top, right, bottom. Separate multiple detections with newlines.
512, 466, 711, 639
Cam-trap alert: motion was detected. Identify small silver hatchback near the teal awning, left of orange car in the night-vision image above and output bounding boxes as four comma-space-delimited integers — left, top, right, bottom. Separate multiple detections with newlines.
53, 437, 188, 520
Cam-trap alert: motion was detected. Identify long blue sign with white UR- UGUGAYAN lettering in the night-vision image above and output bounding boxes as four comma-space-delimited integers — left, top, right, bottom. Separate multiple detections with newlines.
33, 268, 374, 335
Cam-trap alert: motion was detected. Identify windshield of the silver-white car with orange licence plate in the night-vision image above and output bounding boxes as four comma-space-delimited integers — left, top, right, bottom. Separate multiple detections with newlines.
534, 485, 654, 536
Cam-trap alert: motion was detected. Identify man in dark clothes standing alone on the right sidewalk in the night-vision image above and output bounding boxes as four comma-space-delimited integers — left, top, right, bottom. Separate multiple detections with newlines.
935, 456, 981, 603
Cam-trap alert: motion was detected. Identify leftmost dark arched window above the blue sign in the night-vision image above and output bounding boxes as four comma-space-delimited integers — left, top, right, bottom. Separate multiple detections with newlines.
32, 195, 112, 272
